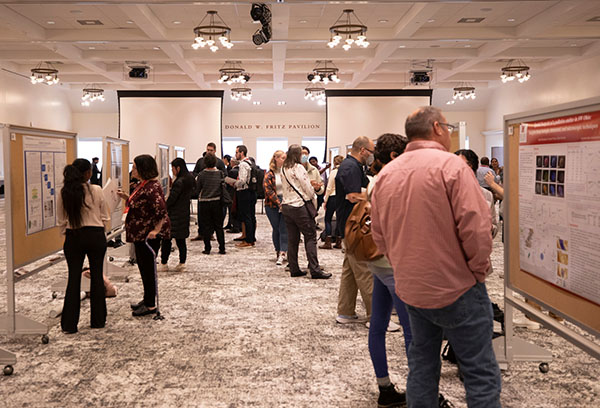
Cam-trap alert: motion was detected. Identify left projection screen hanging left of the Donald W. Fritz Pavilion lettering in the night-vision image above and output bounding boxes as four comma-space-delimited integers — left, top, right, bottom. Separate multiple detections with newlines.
118, 91, 223, 163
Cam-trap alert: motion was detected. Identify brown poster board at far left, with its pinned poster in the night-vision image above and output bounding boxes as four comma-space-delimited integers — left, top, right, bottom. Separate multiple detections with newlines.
3, 125, 77, 268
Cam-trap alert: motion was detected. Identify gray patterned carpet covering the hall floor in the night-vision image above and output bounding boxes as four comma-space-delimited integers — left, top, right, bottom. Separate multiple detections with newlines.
0, 200, 600, 408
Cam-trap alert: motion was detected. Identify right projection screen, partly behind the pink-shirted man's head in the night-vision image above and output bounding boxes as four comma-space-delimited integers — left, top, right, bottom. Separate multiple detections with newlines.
326, 89, 433, 158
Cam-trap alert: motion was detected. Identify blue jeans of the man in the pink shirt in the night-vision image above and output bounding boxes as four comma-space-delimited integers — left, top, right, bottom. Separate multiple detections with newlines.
406, 283, 502, 408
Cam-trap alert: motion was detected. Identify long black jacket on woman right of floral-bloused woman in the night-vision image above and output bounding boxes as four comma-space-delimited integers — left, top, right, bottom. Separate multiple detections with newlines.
167, 174, 194, 238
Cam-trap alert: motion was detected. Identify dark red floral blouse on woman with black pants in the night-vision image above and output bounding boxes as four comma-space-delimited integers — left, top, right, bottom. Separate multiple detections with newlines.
125, 180, 171, 242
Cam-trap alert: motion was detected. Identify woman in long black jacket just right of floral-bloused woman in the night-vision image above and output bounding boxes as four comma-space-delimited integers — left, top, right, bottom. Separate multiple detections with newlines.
158, 157, 195, 272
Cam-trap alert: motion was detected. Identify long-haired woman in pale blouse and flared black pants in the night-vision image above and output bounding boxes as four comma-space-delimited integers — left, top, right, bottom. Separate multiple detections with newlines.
57, 159, 110, 334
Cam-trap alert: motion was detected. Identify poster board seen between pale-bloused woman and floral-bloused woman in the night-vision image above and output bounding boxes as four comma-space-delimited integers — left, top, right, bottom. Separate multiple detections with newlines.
102, 137, 129, 230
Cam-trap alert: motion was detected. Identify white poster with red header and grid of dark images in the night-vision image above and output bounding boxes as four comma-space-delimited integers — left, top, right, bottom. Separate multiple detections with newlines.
518, 111, 600, 304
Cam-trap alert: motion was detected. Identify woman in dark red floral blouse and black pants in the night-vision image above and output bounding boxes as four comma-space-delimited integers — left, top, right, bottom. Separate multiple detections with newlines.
119, 154, 171, 316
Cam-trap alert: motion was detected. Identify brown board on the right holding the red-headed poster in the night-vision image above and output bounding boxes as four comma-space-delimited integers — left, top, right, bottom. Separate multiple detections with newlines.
504, 98, 600, 336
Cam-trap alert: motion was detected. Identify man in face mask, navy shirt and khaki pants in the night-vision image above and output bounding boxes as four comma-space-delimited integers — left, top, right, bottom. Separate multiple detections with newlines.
332, 136, 375, 324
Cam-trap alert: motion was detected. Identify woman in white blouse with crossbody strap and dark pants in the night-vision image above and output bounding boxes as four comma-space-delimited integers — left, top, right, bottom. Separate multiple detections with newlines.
281, 144, 331, 279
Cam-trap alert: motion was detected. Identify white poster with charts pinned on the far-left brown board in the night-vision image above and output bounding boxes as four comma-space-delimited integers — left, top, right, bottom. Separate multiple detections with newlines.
23, 136, 67, 235
